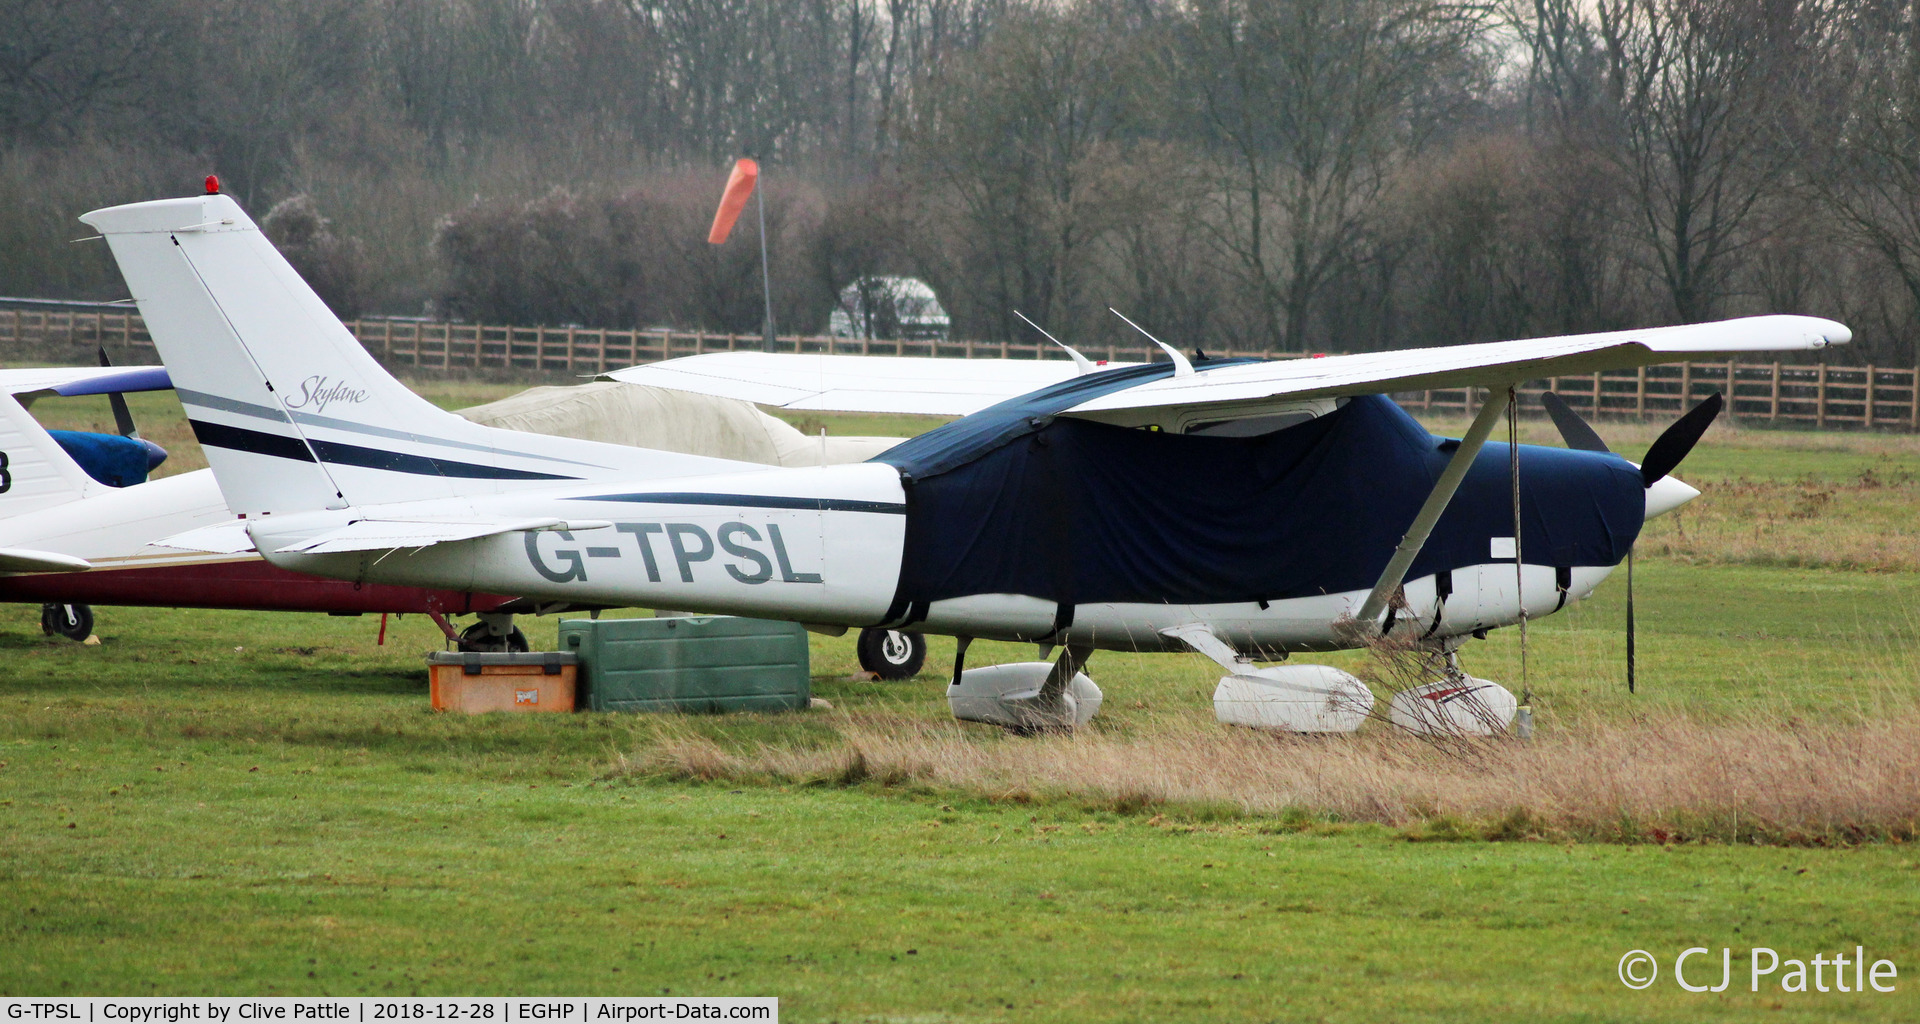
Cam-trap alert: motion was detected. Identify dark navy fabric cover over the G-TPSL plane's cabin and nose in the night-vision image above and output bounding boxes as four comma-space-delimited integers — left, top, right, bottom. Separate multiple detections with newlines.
876, 391, 1645, 607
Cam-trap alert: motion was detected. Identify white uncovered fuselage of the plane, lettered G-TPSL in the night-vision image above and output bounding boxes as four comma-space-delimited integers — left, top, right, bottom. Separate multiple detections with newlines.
250, 450, 1635, 651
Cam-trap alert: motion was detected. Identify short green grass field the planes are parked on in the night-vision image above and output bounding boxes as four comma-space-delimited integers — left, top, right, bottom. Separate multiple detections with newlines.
0, 372, 1920, 1020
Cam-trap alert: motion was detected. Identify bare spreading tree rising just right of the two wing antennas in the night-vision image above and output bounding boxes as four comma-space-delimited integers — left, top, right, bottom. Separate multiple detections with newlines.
1175, 0, 1484, 350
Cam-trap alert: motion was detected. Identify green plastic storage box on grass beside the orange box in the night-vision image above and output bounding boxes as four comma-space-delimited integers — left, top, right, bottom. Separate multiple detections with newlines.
561, 615, 812, 713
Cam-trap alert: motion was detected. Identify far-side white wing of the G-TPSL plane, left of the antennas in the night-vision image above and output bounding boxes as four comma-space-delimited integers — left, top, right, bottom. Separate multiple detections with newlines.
601, 352, 1133, 417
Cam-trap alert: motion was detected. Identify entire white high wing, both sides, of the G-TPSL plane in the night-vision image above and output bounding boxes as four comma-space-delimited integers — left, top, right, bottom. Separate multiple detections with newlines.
605, 315, 1853, 415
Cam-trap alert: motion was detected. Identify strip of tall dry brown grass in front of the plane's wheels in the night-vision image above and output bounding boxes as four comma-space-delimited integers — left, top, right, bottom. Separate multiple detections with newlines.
622, 713, 1920, 843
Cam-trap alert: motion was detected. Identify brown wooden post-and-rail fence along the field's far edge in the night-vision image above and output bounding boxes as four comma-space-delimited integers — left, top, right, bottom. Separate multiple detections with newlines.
0, 309, 1920, 430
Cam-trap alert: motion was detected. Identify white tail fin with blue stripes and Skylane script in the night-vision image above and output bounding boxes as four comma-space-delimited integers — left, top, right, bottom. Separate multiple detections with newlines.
81, 194, 743, 515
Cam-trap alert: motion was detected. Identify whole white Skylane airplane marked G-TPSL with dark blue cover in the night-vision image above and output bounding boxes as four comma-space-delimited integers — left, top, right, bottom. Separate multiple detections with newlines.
83, 194, 1851, 730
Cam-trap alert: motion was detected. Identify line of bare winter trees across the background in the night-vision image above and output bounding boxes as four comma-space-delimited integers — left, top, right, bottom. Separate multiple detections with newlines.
0, 0, 1920, 363
